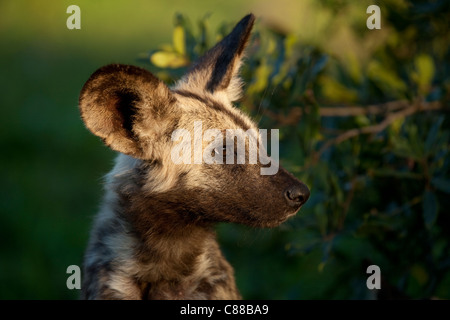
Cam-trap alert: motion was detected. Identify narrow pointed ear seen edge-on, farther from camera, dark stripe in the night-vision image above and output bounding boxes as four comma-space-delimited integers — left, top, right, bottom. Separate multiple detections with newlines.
177, 14, 255, 101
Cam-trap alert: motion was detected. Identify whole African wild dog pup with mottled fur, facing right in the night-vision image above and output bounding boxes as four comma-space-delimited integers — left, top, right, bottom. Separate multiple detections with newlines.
80, 15, 309, 299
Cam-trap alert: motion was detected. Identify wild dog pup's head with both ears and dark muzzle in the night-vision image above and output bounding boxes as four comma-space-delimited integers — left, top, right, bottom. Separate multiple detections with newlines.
80, 15, 309, 227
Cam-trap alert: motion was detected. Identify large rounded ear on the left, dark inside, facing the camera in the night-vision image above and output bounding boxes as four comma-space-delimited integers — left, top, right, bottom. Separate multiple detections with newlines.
79, 64, 176, 160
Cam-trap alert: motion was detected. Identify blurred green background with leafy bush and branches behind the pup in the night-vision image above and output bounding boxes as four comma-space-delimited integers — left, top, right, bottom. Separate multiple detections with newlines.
0, 0, 450, 299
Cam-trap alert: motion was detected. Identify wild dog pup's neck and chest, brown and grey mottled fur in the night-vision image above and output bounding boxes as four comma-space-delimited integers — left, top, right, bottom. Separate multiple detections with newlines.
83, 161, 240, 299
